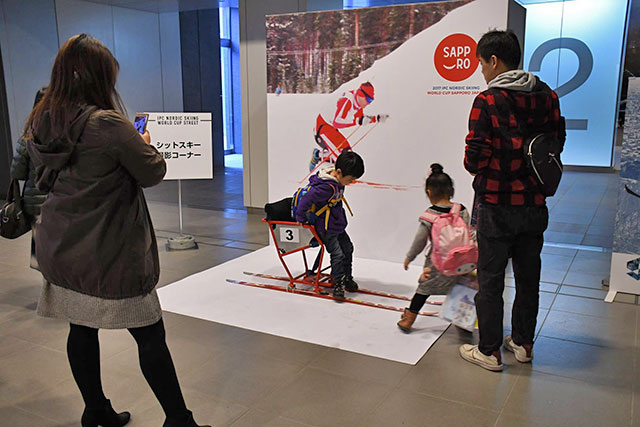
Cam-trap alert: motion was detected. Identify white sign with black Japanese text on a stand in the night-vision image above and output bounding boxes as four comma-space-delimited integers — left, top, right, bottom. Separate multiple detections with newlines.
147, 113, 213, 180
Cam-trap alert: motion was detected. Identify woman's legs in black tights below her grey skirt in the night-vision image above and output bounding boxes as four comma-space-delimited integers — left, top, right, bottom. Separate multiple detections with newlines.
67, 319, 191, 419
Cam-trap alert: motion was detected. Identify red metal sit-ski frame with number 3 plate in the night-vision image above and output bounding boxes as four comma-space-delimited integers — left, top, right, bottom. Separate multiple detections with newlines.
262, 218, 333, 293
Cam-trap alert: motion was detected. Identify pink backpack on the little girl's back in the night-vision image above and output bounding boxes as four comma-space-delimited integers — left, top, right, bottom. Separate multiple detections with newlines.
420, 203, 478, 276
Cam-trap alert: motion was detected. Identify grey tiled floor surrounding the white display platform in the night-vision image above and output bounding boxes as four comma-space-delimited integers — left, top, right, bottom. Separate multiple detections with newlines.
0, 169, 640, 427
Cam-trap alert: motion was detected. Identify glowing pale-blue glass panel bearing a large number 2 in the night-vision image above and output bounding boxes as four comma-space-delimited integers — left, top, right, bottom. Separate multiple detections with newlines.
520, 0, 628, 167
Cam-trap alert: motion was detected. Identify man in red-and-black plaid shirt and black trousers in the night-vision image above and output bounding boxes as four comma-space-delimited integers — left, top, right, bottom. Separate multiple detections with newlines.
460, 31, 565, 371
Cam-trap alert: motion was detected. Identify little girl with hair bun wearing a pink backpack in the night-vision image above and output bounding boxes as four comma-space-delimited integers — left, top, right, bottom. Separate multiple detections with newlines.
398, 163, 477, 332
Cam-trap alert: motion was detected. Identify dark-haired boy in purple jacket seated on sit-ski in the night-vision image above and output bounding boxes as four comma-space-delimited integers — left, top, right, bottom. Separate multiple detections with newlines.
294, 150, 364, 299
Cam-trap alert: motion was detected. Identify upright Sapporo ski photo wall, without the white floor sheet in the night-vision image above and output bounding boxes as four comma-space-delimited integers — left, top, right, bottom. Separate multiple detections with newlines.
267, 0, 524, 262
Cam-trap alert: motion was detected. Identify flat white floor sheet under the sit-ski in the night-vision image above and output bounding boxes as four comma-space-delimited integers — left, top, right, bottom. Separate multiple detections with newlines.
158, 246, 449, 364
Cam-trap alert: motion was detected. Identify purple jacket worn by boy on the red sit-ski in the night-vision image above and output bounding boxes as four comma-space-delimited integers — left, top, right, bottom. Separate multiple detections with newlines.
296, 168, 347, 234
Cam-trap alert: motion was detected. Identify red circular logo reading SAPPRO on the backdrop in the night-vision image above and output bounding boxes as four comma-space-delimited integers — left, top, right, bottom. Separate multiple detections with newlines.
433, 33, 478, 82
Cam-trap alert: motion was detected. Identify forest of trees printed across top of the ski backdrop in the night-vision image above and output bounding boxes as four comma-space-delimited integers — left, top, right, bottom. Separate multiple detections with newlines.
267, 0, 473, 93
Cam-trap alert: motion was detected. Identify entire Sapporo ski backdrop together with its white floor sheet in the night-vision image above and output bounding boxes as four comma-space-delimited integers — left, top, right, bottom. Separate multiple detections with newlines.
158, 0, 524, 364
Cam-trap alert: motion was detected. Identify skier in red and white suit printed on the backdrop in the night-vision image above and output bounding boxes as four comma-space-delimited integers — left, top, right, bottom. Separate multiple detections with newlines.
309, 82, 389, 171
